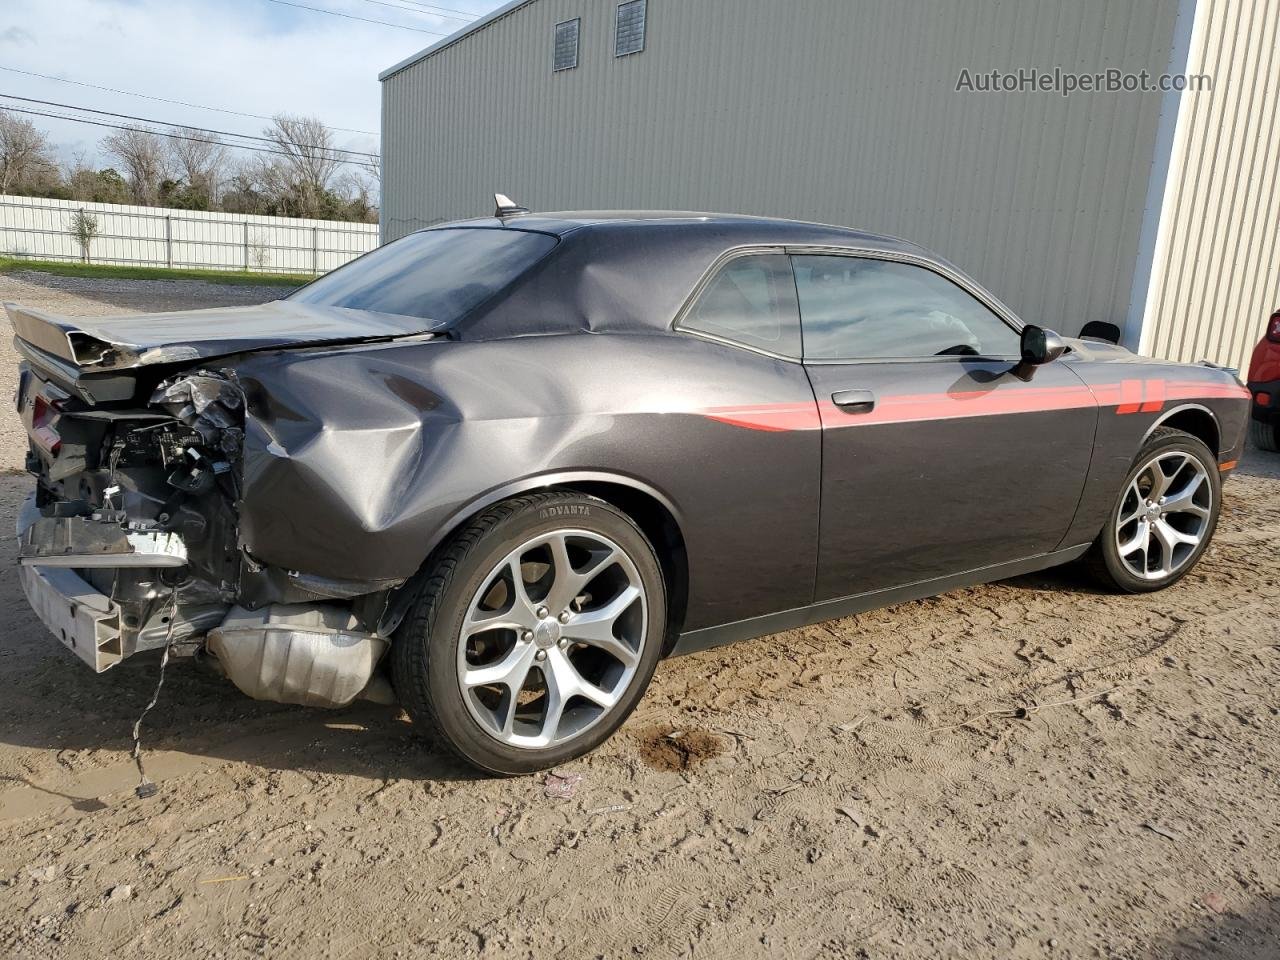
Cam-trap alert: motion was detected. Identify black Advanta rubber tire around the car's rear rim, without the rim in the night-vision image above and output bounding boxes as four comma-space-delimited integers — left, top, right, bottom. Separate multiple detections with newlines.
392, 492, 667, 774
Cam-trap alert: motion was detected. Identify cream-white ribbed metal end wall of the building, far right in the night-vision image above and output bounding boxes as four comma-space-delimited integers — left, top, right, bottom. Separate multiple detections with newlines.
1140, 0, 1280, 374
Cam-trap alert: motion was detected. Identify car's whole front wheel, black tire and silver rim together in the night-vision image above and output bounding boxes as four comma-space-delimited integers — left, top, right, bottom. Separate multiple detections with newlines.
1091, 428, 1222, 593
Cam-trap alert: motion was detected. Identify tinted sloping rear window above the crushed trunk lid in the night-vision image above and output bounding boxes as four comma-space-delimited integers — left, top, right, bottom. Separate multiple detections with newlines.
289, 228, 557, 326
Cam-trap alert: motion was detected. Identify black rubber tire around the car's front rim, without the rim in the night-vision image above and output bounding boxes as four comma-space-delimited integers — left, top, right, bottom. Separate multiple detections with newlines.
1085, 426, 1222, 594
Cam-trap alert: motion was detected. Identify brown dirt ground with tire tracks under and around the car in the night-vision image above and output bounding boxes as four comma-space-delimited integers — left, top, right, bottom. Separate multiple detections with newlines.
0, 274, 1280, 960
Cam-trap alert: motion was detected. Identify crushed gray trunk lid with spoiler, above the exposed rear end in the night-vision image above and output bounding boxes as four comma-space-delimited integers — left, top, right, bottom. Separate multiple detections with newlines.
4, 300, 440, 371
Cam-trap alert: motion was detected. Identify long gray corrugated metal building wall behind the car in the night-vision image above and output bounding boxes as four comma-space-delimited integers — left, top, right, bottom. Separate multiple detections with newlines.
383, 0, 1178, 333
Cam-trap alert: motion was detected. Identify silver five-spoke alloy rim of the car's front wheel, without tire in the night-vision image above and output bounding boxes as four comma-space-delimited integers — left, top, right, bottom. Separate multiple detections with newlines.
1116, 451, 1213, 580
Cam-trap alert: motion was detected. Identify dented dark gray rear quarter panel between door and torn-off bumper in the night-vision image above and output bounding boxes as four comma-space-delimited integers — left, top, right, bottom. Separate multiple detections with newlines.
237, 333, 820, 628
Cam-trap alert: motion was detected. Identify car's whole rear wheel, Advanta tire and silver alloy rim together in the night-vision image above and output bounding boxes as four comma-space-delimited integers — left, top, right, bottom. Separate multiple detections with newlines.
392, 493, 666, 774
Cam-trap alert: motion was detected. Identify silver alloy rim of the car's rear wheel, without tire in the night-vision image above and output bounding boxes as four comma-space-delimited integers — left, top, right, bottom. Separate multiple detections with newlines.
457, 530, 646, 749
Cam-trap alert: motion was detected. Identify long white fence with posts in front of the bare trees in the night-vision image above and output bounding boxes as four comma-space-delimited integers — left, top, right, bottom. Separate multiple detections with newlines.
0, 195, 378, 274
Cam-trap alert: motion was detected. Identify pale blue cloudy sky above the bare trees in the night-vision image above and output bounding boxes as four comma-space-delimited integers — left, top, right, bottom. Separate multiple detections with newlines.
0, 0, 502, 165
